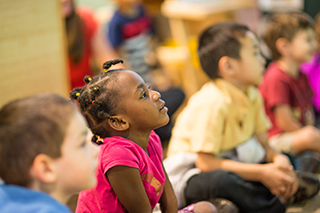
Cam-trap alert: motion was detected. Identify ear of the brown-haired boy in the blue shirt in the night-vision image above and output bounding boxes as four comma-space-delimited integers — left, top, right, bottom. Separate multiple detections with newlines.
30, 154, 57, 183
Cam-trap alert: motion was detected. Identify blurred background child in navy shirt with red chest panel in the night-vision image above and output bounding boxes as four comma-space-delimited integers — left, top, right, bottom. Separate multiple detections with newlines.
107, 0, 185, 142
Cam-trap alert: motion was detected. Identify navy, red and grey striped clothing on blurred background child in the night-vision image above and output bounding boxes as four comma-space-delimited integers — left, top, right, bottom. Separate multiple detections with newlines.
108, 6, 153, 82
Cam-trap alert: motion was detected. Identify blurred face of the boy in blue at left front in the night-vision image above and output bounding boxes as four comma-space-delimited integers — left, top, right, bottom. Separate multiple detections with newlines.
54, 112, 98, 196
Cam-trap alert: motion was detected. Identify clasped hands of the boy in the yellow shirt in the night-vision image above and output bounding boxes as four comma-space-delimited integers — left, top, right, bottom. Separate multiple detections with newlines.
261, 163, 297, 196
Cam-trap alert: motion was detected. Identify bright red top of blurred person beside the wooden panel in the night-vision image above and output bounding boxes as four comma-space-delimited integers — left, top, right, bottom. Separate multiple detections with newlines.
68, 7, 98, 88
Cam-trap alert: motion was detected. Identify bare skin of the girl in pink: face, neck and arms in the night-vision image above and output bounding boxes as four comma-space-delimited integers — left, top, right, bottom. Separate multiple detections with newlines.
105, 71, 178, 213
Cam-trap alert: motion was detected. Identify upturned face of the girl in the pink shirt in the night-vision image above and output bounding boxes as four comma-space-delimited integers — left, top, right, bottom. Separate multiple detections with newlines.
118, 71, 169, 132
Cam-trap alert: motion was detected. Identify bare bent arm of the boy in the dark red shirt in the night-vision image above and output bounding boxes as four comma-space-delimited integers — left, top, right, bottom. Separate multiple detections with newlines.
274, 104, 302, 132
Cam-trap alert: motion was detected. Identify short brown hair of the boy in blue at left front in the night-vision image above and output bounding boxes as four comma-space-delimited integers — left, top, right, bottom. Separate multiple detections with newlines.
0, 94, 77, 187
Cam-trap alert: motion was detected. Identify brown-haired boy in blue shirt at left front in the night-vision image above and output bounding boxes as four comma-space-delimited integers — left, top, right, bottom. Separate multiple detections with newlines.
0, 94, 97, 213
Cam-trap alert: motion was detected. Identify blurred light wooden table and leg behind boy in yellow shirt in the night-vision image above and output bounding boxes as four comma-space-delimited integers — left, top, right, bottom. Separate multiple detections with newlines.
161, 0, 256, 97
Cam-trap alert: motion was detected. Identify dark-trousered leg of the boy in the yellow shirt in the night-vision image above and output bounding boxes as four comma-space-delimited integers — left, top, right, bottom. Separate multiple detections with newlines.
184, 170, 286, 213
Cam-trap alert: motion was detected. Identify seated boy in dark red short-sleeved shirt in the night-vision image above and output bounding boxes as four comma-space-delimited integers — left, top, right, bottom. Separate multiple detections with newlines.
260, 11, 320, 169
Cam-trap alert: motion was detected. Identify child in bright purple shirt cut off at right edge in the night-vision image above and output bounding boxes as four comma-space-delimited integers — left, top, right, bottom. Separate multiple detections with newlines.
301, 12, 320, 128
